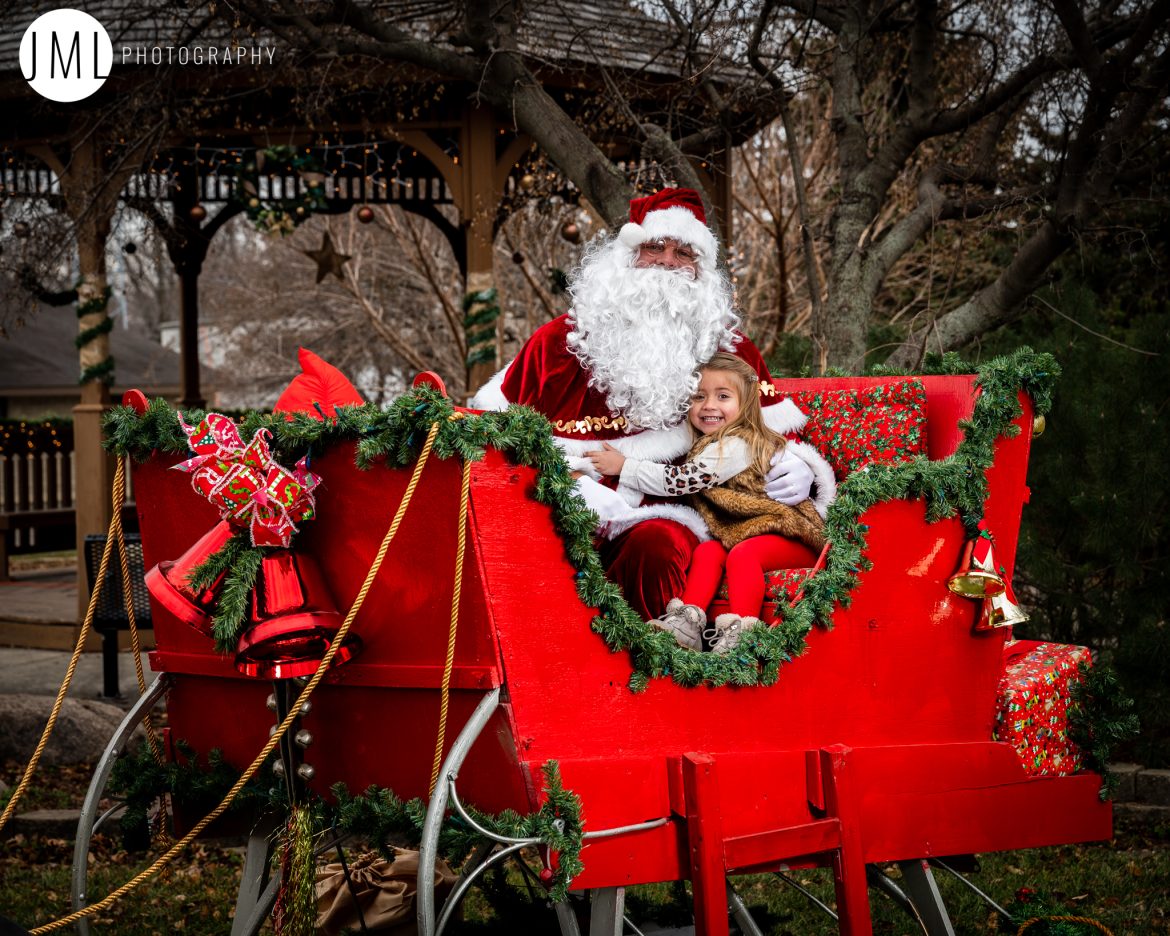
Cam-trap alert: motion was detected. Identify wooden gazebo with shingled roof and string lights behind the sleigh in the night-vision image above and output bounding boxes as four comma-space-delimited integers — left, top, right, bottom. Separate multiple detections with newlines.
0, 0, 732, 599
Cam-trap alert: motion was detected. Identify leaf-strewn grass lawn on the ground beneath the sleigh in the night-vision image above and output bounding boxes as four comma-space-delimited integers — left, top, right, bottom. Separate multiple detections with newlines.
0, 765, 1170, 936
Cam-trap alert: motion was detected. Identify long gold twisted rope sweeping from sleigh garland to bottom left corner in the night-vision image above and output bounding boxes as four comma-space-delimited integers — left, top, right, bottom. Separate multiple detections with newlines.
30, 422, 439, 936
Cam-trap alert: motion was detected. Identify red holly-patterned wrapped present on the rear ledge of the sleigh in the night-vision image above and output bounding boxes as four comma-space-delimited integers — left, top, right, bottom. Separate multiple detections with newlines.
995, 640, 1092, 777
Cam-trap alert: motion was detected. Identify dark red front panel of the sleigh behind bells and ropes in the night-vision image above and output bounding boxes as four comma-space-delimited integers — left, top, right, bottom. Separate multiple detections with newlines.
135, 446, 532, 811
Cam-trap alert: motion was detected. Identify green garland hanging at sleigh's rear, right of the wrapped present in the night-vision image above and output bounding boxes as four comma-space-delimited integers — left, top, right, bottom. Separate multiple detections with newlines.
1068, 663, 1142, 800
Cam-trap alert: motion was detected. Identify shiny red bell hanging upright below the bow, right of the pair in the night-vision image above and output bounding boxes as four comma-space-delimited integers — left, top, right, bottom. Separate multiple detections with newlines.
235, 549, 358, 680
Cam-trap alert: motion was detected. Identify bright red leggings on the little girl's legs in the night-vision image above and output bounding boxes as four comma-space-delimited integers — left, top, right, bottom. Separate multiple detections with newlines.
682, 534, 817, 618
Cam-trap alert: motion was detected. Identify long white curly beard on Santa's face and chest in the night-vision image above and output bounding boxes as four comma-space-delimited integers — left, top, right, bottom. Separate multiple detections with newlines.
567, 241, 739, 429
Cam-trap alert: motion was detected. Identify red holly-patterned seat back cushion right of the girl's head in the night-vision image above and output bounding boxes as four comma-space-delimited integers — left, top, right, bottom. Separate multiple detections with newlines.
791, 378, 927, 481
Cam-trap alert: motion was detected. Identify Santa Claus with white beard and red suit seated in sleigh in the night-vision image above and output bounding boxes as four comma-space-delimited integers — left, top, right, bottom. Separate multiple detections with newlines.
472, 188, 837, 619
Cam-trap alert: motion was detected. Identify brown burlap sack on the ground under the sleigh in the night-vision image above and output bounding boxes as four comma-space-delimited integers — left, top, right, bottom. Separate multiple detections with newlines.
317, 848, 455, 936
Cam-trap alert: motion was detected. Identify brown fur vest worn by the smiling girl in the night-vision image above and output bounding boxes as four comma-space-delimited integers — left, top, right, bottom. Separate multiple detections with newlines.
690, 468, 825, 552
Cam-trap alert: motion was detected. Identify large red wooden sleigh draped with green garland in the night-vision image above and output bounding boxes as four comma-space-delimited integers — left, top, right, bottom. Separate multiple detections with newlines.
68, 356, 1112, 935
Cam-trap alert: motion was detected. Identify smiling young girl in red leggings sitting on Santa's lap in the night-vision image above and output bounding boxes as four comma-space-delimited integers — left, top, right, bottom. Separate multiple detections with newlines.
586, 351, 825, 653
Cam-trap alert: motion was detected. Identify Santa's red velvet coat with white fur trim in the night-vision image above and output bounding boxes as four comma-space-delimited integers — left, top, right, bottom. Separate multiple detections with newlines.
472, 315, 837, 539
